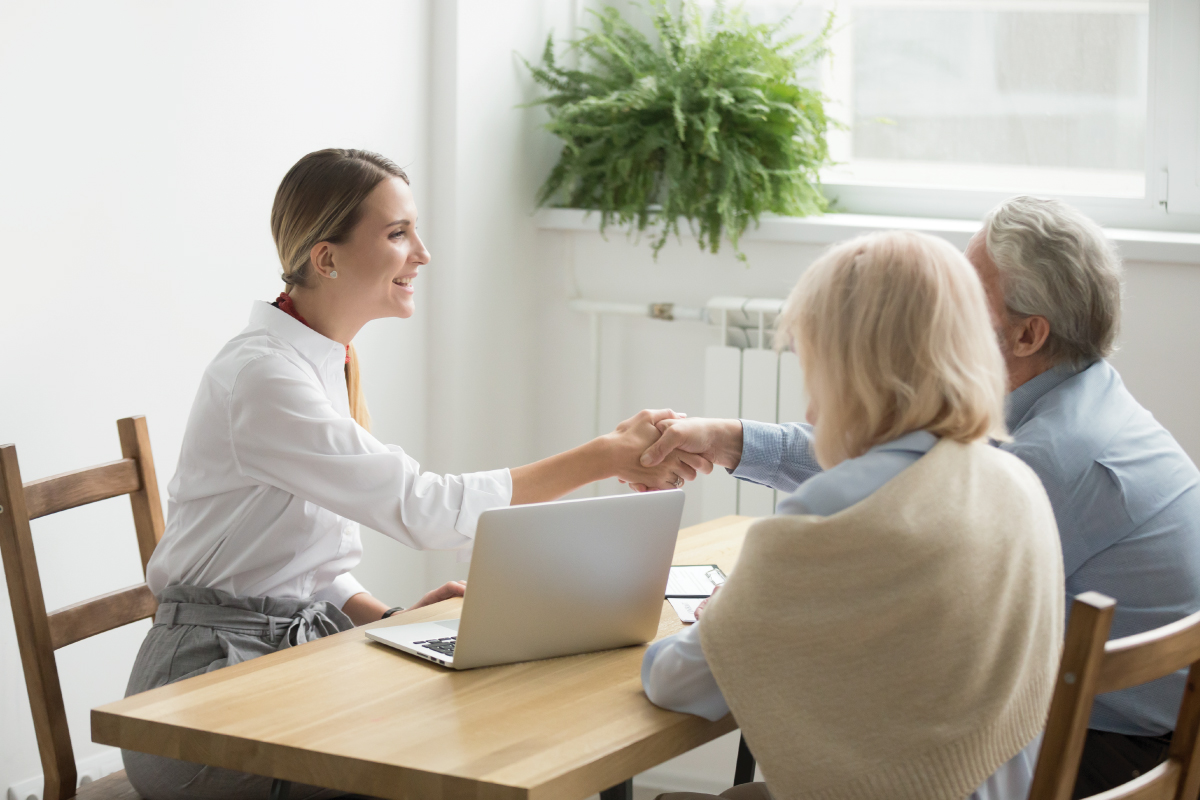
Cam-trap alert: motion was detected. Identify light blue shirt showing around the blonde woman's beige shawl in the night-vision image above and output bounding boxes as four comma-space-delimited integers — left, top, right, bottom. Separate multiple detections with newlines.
642, 434, 1042, 800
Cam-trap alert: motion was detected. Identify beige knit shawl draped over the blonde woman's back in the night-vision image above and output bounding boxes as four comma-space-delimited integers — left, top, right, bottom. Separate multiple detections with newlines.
701, 439, 1064, 800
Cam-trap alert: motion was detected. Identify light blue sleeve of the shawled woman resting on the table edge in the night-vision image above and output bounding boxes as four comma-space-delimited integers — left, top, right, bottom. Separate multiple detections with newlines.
642, 622, 730, 722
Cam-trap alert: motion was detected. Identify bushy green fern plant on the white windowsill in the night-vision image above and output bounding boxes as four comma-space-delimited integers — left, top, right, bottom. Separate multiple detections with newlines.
526, 0, 833, 260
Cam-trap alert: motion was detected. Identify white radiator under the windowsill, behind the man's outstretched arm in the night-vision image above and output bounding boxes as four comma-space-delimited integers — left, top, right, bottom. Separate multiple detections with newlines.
701, 297, 808, 519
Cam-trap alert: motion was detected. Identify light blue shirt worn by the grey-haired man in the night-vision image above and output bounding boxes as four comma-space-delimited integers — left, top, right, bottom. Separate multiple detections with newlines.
733, 360, 1200, 735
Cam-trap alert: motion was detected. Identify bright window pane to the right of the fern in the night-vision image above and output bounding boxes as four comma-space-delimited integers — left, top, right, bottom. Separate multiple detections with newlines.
830, 0, 1150, 198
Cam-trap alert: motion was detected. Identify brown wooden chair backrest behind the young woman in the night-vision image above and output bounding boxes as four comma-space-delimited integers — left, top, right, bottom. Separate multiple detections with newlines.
0, 416, 163, 800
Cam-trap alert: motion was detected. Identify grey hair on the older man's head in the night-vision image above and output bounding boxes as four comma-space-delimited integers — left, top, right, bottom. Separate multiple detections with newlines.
983, 197, 1122, 363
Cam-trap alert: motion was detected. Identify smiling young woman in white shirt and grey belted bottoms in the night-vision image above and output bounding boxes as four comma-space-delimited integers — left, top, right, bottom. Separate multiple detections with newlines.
124, 150, 710, 800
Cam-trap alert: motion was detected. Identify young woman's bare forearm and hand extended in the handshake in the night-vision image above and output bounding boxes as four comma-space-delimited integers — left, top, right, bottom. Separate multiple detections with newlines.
509, 409, 713, 505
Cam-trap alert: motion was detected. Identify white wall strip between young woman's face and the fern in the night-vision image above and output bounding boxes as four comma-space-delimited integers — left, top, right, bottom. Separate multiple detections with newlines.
412, 0, 580, 587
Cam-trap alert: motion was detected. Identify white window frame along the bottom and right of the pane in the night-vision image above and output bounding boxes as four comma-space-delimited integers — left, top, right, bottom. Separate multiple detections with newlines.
823, 0, 1200, 231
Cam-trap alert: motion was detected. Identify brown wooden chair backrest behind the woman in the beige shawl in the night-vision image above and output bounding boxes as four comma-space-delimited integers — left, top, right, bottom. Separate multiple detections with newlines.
1030, 591, 1200, 800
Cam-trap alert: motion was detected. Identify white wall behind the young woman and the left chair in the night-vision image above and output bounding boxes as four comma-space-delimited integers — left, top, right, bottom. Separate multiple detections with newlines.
0, 0, 437, 792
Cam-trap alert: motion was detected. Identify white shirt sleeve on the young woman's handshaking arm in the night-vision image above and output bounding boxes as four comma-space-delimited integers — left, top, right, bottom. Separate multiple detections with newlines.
229, 355, 512, 549
